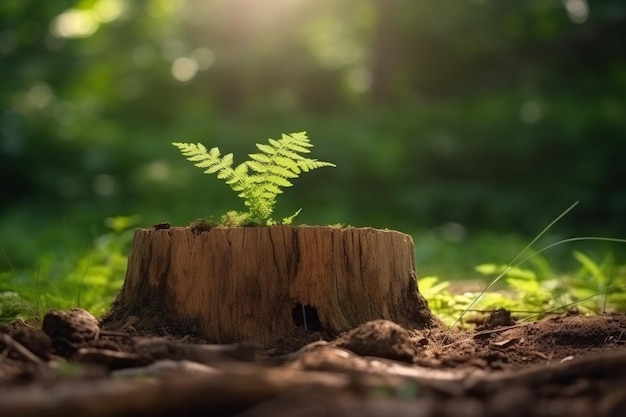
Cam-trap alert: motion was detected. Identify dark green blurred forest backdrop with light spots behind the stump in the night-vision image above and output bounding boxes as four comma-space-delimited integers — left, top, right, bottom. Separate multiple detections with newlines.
0, 0, 626, 278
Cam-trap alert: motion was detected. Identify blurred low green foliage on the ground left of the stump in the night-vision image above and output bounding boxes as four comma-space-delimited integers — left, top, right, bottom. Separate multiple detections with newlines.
0, 216, 133, 323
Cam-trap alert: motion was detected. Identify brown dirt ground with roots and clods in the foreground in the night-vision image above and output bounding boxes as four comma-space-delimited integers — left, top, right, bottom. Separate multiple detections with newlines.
0, 309, 626, 417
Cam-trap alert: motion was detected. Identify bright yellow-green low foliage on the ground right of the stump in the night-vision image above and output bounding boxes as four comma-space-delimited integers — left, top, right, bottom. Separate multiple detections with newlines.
418, 247, 626, 326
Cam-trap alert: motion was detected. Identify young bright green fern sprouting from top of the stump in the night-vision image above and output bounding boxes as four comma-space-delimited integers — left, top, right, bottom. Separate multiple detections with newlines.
172, 132, 335, 226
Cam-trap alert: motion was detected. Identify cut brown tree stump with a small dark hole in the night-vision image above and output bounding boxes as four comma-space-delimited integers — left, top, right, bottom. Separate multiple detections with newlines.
104, 226, 437, 347
